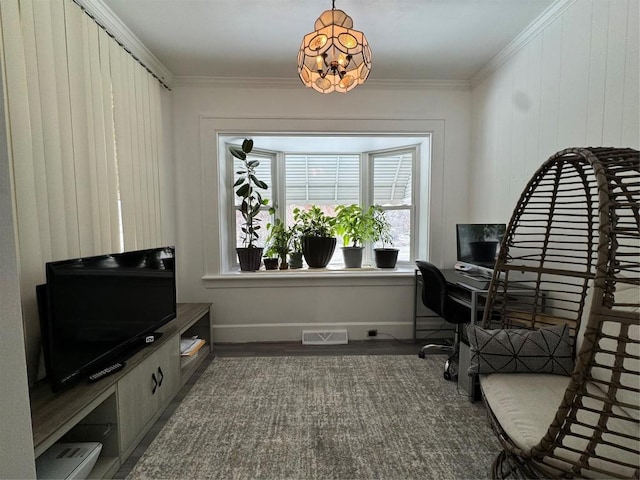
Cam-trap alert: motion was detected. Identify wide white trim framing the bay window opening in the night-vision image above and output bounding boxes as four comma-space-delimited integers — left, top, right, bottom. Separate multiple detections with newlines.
202, 115, 442, 282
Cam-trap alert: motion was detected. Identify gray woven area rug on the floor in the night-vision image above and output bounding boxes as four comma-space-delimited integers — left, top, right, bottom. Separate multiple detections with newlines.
127, 355, 500, 480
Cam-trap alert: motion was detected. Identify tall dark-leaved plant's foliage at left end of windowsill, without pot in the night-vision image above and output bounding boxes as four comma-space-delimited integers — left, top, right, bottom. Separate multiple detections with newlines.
229, 139, 268, 248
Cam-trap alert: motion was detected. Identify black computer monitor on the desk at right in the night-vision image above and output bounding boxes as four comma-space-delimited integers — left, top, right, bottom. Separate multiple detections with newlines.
456, 223, 507, 268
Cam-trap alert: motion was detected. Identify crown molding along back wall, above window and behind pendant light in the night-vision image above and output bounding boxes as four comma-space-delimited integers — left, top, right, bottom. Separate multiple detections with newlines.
173, 75, 471, 91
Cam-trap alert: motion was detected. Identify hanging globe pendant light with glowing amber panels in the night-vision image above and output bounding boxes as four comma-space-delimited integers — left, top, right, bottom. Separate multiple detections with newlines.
298, 0, 371, 93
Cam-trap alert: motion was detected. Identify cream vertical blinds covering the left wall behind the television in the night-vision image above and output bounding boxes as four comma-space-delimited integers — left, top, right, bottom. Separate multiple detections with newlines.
0, 0, 162, 380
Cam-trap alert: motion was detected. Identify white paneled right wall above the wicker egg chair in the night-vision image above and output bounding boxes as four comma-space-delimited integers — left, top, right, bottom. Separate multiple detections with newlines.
469, 0, 640, 221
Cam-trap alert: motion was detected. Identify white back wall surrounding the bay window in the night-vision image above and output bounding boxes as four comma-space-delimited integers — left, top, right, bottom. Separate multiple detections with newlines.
173, 79, 471, 341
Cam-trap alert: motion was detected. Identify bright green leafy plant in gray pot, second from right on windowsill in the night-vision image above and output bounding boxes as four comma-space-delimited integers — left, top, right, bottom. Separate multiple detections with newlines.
336, 204, 375, 268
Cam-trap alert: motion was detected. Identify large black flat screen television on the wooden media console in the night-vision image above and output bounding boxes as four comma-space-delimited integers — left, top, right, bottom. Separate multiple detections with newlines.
38, 247, 176, 392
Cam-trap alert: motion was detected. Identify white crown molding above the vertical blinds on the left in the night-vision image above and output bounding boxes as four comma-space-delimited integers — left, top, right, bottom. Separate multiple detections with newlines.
73, 0, 173, 88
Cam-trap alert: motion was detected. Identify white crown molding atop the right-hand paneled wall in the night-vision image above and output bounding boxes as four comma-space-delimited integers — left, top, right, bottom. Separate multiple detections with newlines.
470, 0, 576, 88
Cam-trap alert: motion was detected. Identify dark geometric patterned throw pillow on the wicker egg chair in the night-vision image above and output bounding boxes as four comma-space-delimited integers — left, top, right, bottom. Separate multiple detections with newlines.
467, 325, 573, 375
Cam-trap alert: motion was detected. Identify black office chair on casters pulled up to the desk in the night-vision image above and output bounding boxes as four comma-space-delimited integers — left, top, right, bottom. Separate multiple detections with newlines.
416, 260, 470, 380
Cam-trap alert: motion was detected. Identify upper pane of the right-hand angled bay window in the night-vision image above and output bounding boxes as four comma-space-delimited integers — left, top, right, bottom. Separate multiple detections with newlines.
373, 152, 413, 206
